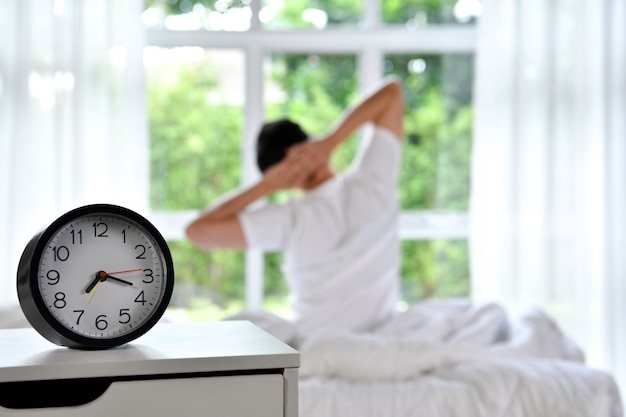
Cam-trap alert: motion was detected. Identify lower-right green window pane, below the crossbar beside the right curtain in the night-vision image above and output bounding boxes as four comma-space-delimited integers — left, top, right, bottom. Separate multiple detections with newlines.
401, 240, 470, 304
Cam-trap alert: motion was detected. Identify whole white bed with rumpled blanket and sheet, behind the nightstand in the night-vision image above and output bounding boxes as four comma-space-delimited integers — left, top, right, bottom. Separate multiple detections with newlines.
292, 300, 623, 417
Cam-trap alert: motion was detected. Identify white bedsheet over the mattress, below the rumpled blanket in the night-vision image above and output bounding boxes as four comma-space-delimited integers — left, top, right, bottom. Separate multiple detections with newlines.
299, 359, 623, 417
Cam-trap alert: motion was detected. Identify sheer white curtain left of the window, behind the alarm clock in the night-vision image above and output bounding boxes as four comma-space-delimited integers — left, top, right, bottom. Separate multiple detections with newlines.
0, 0, 148, 306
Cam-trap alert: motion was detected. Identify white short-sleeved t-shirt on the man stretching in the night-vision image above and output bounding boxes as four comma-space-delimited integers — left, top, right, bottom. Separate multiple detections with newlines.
239, 127, 401, 335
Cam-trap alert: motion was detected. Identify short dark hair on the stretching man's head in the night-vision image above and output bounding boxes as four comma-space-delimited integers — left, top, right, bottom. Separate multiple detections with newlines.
256, 119, 308, 172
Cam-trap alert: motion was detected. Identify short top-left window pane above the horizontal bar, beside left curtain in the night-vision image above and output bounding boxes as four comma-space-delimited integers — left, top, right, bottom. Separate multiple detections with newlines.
142, 0, 252, 31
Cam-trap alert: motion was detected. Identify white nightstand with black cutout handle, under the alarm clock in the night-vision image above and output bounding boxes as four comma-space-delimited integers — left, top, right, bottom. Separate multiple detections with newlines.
0, 321, 300, 417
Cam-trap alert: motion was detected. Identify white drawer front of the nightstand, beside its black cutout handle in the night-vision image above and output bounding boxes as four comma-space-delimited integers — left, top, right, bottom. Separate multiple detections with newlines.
0, 374, 285, 417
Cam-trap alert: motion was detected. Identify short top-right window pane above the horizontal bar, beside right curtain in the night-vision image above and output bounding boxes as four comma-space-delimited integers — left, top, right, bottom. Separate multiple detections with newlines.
380, 0, 483, 28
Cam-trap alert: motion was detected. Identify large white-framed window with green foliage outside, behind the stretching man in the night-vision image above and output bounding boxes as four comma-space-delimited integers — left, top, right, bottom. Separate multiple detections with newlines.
143, 0, 481, 320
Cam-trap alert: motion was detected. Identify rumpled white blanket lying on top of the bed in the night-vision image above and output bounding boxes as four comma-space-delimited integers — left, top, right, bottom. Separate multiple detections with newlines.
299, 301, 584, 381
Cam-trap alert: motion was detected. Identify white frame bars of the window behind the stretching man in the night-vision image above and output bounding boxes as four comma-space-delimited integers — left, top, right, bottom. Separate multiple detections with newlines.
146, 0, 476, 309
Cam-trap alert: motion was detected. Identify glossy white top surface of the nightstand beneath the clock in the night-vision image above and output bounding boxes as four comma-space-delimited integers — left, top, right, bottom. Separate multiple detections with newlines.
0, 321, 300, 383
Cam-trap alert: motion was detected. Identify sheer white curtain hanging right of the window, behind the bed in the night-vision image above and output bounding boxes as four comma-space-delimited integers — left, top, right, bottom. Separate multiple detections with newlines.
470, 0, 626, 386
